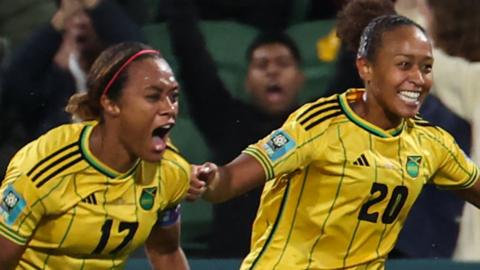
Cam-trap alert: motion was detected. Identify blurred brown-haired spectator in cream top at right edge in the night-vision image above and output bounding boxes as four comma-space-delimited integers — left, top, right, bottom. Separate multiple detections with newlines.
412, 0, 480, 261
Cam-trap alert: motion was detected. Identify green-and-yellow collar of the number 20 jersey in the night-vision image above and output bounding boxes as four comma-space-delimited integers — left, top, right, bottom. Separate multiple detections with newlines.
338, 89, 405, 138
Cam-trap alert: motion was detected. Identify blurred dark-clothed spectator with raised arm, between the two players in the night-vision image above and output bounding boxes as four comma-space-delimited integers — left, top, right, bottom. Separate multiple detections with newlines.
165, 0, 304, 257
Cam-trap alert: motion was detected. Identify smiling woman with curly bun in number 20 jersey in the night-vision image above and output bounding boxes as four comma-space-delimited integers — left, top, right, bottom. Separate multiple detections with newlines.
190, 0, 480, 270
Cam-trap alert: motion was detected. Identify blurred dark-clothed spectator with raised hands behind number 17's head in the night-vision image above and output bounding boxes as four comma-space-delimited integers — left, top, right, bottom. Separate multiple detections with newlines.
0, 0, 141, 177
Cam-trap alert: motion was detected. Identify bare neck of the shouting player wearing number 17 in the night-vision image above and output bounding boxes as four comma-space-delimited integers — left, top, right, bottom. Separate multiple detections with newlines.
89, 123, 138, 173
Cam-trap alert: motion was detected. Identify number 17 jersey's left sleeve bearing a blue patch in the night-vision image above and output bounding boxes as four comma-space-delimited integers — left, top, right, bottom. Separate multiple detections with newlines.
0, 170, 46, 245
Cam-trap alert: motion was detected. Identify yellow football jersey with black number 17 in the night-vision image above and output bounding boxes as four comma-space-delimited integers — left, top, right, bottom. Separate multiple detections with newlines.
0, 122, 190, 269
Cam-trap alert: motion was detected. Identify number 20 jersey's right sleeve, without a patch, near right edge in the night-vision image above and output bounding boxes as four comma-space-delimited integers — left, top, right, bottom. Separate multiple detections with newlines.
431, 131, 479, 189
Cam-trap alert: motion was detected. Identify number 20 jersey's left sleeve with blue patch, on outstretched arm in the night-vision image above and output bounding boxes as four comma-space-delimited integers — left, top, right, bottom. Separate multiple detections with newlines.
243, 110, 323, 181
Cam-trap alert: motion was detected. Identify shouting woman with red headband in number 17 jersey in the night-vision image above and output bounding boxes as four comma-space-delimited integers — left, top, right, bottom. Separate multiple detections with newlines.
0, 43, 190, 269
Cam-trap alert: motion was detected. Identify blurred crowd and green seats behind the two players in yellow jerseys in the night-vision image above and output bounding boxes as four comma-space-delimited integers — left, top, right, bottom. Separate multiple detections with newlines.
0, 0, 480, 260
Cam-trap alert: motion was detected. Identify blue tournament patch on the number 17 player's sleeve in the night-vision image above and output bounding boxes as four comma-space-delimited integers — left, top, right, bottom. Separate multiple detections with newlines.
0, 185, 26, 225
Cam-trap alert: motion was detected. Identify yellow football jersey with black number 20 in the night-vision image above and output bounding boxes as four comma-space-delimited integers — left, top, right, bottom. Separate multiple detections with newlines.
241, 89, 478, 270
